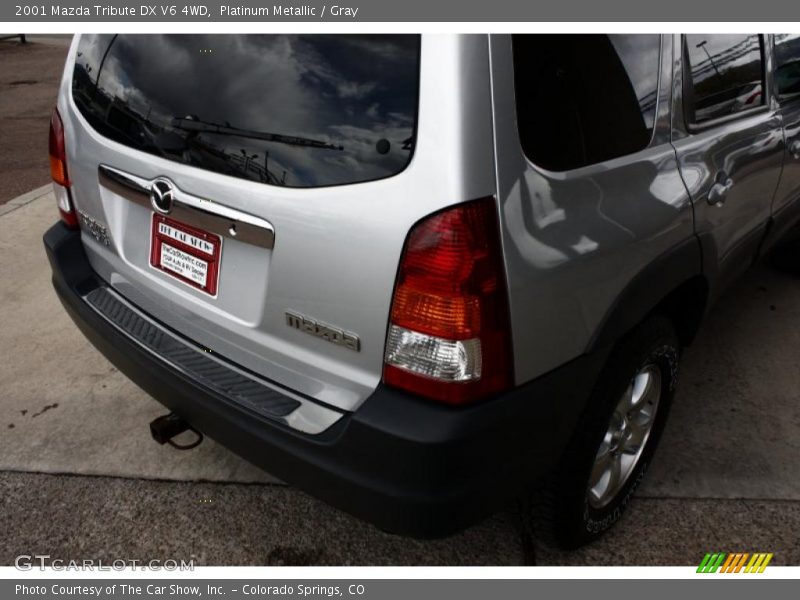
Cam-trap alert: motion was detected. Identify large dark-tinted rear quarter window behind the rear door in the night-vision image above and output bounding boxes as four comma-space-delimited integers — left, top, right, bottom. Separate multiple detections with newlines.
512, 35, 661, 171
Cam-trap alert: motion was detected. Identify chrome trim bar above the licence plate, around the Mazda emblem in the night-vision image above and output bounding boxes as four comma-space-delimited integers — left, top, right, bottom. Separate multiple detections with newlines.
97, 165, 275, 250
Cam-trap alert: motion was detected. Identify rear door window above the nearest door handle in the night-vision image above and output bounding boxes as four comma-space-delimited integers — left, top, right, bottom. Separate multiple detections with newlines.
684, 34, 765, 123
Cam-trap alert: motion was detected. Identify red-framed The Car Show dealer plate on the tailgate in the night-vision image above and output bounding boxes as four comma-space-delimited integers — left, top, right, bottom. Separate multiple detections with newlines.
150, 212, 222, 298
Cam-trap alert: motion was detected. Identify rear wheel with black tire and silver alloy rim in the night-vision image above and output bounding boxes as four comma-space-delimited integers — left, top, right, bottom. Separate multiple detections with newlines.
523, 317, 680, 549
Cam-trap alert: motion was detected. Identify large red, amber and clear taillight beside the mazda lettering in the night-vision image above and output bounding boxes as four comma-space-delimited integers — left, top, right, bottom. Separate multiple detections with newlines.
383, 198, 513, 404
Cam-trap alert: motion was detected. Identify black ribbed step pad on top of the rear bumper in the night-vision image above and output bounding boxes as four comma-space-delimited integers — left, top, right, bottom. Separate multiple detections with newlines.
85, 286, 301, 421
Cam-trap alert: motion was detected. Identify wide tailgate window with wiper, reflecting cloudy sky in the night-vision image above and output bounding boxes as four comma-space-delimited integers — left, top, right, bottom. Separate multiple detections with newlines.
72, 35, 419, 187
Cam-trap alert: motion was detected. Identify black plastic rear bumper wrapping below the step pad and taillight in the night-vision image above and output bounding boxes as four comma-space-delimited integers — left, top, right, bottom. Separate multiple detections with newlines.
44, 223, 603, 537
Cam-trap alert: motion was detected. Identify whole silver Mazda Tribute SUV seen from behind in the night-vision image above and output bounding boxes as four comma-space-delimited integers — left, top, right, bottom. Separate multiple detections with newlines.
44, 34, 800, 547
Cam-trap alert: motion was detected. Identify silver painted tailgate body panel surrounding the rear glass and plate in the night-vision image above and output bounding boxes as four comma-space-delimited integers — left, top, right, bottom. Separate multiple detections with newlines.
58, 36, 495, 410
